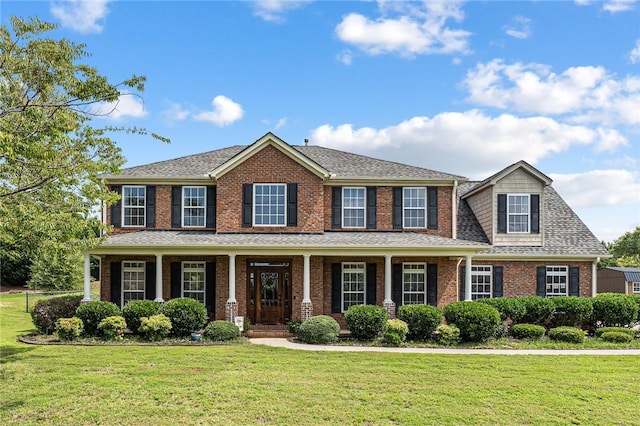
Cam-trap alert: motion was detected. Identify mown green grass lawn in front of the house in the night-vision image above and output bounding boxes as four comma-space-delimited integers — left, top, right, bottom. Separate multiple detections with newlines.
0, 295, 640, 425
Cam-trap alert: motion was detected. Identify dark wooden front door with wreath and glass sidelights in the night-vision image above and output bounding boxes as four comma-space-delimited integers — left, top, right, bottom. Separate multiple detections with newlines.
247, 262, 291, 324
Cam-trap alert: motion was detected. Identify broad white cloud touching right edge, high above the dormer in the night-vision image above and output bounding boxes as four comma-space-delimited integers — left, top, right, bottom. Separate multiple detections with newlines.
462, 59, 640, 125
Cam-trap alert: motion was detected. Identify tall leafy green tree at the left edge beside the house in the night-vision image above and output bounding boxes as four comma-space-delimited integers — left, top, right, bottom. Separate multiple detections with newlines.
0, 17, 168, 290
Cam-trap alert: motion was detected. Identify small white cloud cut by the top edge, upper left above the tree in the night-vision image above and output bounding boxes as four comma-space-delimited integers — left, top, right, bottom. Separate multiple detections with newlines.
50, 0, 111, 34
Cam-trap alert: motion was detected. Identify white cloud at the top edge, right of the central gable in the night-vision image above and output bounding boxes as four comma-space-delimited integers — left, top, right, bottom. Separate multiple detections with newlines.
336, 1, 471, 58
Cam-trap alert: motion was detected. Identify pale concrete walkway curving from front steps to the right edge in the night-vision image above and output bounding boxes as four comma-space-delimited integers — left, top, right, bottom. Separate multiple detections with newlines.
249, 337, 640, 355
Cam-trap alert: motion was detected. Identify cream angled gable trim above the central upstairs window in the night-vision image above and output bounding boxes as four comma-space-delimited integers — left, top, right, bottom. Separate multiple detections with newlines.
208, 132, 331, 179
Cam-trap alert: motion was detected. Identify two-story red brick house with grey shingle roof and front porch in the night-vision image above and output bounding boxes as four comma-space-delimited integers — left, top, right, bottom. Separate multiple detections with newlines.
85, 133, 607, 324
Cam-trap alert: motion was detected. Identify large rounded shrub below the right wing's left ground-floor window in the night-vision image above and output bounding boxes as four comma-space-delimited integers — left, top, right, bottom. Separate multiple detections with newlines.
444, 302, 500, 342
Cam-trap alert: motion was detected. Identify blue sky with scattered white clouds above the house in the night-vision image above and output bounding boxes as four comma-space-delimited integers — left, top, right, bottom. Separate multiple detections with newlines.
5, 0, 640, 241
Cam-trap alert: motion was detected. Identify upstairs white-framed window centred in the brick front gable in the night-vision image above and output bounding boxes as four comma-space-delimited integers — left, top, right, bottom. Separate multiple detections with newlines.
253, 183, 287, 226
